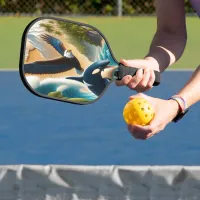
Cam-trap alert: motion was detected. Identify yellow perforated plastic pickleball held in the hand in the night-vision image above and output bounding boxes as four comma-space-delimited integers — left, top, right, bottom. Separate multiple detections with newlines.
123, 98, 155, 126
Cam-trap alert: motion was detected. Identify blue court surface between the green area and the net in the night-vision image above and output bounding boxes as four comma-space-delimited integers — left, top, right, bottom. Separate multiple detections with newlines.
0, 71, 200, 165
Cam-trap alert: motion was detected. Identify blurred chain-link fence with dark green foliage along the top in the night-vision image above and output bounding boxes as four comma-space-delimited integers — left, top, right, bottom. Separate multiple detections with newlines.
0, 0, 193, 16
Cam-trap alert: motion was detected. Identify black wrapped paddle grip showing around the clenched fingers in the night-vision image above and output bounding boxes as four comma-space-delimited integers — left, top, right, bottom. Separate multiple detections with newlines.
115, 63, 160, 86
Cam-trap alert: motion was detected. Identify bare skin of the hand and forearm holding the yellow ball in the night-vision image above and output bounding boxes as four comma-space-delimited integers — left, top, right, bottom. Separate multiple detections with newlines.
128, 66, 200, 140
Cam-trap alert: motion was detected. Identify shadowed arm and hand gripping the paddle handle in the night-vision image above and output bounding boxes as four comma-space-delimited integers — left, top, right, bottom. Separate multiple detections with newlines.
116, 0, 187, 92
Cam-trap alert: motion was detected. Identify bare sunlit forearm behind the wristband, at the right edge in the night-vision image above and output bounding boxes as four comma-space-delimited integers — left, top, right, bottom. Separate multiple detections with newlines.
177, 65, 200, 107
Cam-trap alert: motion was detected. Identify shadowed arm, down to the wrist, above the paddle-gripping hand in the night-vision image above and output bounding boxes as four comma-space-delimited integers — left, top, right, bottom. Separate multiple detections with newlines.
147, 0, 187, 72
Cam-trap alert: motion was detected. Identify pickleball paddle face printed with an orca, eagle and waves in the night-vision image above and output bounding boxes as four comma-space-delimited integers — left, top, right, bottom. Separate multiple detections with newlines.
20, 18, 118, 104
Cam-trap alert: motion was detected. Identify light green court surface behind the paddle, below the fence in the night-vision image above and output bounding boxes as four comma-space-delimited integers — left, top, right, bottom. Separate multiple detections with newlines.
0, 17, 200, 69
